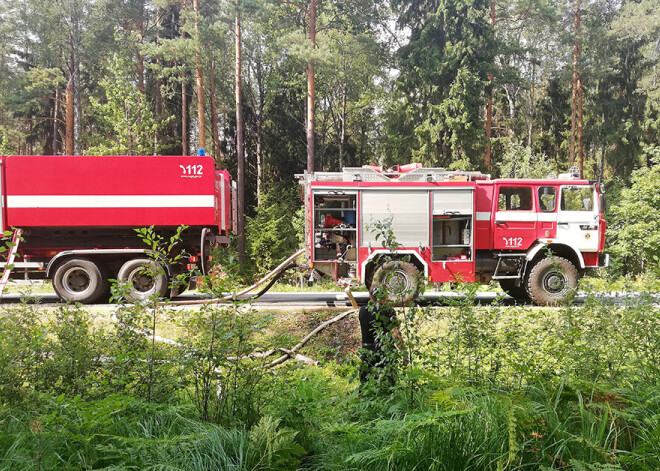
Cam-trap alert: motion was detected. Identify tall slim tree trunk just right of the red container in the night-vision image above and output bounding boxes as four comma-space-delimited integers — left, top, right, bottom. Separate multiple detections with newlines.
235, 4, 245, 263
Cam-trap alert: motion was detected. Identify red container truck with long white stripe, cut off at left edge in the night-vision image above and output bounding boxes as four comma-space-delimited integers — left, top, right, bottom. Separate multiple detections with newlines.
0, 156, 233, 303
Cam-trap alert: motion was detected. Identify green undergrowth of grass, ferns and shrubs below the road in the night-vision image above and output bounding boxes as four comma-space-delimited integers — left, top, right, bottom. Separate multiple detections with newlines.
0, 285, 660, 470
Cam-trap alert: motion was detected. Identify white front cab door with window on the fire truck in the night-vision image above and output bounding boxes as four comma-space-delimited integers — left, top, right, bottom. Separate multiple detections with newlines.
557, 185, 600, 252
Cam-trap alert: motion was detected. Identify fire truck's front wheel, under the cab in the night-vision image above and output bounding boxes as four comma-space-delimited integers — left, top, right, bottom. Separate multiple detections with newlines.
527, 257, 578, 306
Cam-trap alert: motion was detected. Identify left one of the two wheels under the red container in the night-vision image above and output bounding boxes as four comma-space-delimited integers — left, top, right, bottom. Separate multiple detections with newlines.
53, 258, 107, 304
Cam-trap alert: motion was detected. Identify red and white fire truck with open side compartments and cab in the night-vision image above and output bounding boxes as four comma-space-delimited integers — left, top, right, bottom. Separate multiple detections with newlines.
300, 164, 608, 305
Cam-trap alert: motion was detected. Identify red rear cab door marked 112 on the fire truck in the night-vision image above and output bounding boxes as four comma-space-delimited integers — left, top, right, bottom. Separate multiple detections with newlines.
493, 183, 538, 250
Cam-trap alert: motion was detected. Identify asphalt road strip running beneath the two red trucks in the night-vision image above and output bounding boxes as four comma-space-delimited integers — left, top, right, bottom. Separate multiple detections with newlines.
1, 291, 637, 307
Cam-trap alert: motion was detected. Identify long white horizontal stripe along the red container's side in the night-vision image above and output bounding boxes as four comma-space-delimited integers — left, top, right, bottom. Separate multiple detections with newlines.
7, 195, 215, 209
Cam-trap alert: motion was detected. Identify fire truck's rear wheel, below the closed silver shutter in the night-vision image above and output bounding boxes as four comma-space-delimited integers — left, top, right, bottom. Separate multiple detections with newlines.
369, 261, 420, 306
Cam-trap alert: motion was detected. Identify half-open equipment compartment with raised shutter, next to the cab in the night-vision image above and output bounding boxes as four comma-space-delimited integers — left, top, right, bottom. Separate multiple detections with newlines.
431, 188, 474, 261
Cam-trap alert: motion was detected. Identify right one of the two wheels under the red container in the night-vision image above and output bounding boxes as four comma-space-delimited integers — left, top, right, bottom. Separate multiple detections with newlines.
117, 258, 169, 301
